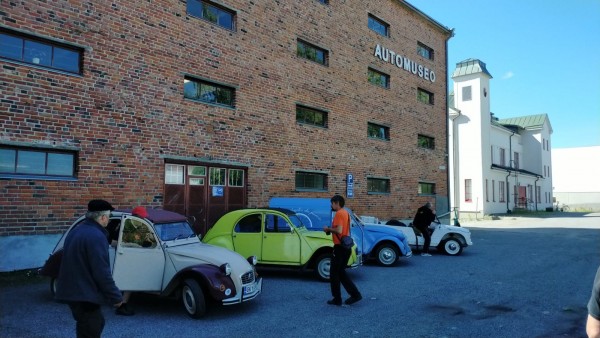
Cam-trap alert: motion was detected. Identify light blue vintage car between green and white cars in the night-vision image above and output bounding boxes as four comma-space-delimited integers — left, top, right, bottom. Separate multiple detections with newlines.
269, 197, 412, 266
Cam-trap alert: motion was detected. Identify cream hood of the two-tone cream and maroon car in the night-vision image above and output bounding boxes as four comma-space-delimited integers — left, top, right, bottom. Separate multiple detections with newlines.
166, 242, 252, 274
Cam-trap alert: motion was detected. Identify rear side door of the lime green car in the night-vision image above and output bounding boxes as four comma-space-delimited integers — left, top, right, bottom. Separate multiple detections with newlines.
231, 212, 263, 263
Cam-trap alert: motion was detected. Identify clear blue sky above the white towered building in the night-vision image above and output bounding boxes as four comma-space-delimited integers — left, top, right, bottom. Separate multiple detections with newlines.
408, 0, 600, 148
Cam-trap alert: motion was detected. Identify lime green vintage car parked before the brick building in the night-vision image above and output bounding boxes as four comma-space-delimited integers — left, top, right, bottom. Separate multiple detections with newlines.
202, 208, 361, 281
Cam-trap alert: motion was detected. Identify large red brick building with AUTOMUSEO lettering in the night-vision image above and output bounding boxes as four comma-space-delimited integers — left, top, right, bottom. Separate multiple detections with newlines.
0, 0, 452, 270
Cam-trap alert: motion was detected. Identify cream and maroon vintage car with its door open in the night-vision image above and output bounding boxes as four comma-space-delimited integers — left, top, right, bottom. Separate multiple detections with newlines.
40, 209, 262, 318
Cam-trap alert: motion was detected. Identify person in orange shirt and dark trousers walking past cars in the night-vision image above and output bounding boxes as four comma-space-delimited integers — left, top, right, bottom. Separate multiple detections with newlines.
323, 195, 362, 306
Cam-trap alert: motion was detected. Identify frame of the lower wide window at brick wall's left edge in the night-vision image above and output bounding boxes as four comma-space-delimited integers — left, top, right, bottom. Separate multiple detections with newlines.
0, 144, 79, 181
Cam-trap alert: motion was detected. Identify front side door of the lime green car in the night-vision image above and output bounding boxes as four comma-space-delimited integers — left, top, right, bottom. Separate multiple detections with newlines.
262, 213, 300, 265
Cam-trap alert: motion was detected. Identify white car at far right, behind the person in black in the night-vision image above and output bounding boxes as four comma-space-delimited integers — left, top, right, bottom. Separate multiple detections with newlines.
365, 220, 473, 256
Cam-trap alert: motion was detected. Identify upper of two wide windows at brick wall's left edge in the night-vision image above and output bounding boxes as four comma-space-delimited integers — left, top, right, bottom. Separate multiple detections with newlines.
0, 29, 83, 74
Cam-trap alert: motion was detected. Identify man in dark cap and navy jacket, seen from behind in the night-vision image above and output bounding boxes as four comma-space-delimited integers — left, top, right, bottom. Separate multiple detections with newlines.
56, 199, 123, 337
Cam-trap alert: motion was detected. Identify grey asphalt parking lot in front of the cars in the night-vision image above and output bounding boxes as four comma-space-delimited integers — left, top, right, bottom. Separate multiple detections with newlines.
0, 213, 600, 337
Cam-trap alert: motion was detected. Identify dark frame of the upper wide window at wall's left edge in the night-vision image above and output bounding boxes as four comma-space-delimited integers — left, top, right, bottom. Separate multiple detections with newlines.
0, 27, 84, 75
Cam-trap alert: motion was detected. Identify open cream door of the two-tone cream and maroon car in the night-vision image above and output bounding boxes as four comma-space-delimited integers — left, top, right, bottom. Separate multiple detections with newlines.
113, 216, 165, 291
